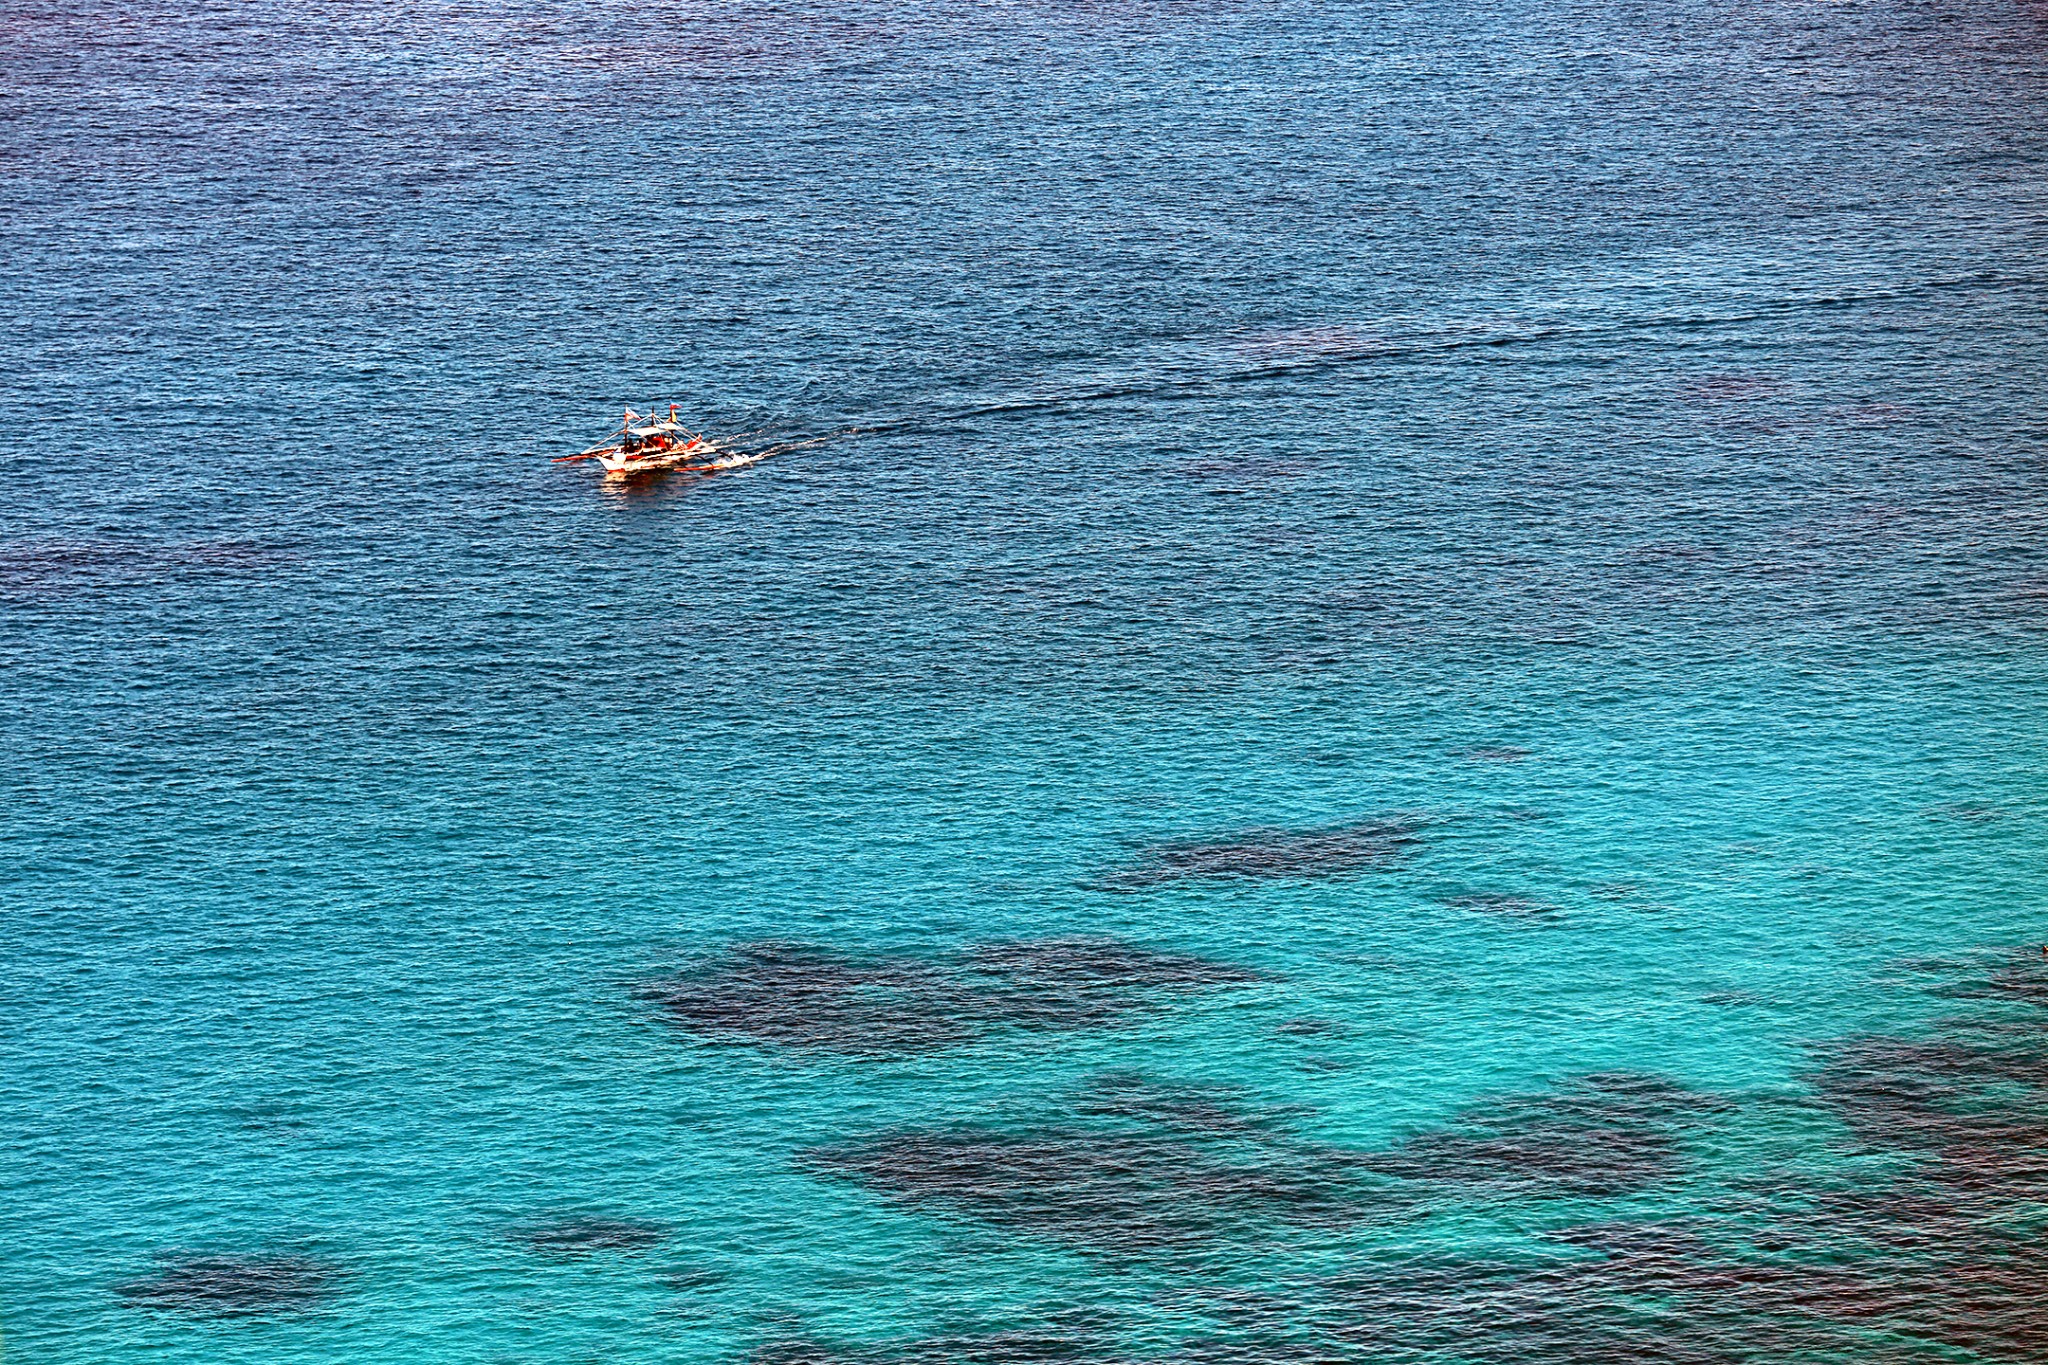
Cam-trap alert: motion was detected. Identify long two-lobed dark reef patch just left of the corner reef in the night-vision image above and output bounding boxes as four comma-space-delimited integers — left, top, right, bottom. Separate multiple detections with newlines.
801, 1072, 1726, 1257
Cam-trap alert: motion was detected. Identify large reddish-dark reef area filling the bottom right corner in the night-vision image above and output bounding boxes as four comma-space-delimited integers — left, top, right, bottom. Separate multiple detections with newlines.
1321, 954, 2048, 1365
